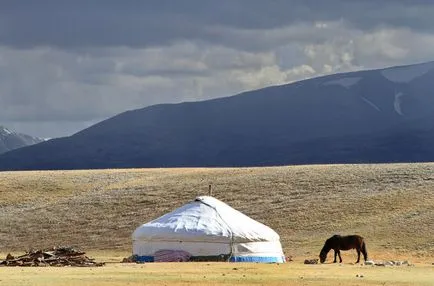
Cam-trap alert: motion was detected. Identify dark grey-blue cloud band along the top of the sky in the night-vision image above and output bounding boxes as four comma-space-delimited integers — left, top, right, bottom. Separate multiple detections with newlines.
0, 0, 434, 48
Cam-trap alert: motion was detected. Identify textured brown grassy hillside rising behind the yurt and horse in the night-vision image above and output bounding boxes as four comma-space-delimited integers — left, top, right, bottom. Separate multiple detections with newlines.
0, 164, 434, 262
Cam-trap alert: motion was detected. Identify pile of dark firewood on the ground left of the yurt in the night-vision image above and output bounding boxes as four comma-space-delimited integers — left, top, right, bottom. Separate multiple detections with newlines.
0, 247, 104, 267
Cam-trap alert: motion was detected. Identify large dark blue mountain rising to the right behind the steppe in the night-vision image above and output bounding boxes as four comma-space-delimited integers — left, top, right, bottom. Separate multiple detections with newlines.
0, 62, 434, 170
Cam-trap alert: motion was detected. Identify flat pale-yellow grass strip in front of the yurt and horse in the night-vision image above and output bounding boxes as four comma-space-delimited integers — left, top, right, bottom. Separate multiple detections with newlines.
0, 263, 434, 286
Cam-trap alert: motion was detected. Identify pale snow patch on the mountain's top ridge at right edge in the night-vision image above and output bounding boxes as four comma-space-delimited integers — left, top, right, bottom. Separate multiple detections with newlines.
381, 62, 434, 83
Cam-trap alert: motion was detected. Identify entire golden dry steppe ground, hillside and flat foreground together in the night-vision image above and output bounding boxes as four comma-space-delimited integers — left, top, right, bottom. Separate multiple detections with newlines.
0, 163, 434, 285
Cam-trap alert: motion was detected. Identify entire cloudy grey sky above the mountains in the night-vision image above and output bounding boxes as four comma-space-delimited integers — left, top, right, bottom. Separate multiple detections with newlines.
0, 0, 434, 137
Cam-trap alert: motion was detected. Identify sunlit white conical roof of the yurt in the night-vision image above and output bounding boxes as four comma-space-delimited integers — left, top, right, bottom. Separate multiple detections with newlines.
133, 196, 280, 243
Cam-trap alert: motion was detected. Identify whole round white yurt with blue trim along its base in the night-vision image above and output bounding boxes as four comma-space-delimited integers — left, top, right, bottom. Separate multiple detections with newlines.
132, 196, 285, 263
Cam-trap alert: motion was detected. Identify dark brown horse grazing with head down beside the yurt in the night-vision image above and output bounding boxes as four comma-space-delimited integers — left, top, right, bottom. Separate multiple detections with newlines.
319, 234, 368, 263
